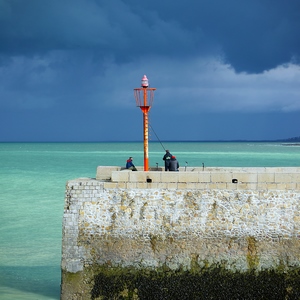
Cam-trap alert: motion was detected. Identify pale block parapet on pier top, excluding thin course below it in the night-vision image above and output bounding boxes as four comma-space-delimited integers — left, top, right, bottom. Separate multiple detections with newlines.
96, 166, 300, 183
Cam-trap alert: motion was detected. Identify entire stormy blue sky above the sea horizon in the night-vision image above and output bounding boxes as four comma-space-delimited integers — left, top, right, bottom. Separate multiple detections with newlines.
0, 0, 300, 142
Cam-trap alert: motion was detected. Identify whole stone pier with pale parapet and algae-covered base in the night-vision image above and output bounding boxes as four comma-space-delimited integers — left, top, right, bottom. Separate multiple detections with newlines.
61, 166, 300, 300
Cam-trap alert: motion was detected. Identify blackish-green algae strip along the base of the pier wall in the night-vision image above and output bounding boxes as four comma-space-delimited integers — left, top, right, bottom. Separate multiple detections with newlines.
82, 267, 300, 300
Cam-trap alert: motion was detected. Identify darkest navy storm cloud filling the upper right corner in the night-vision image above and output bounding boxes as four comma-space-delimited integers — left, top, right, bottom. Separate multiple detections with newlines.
127, 0, 300, 72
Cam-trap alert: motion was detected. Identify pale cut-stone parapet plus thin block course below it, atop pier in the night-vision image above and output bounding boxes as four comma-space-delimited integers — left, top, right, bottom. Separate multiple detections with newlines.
96, 166, 300, 190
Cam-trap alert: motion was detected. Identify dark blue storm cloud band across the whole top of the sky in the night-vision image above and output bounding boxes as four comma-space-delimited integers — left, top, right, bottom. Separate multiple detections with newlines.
0, 0, 300, 72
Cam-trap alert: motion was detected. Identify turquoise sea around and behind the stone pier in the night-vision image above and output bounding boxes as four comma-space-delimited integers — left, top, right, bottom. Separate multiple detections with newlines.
0, 142, 300, 300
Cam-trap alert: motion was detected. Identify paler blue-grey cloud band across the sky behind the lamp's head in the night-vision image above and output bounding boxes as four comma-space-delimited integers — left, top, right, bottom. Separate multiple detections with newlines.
0, 52, 300, 113
